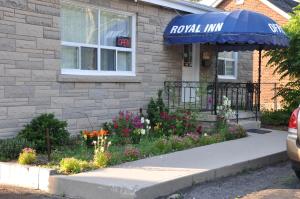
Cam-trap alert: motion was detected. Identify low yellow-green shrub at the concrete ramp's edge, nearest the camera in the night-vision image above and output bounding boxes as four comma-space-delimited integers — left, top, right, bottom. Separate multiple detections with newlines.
59, 158, 91, 174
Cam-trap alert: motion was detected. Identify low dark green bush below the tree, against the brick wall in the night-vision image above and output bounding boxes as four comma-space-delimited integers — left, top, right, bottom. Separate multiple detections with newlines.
261, 110, 291, 126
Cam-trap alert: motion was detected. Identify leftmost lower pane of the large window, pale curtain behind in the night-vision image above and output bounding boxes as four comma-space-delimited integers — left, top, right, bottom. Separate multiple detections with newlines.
62, 46, 79, 69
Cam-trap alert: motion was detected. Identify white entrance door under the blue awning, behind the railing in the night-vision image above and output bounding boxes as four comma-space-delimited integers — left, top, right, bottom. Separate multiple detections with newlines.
181, 44, 200, 103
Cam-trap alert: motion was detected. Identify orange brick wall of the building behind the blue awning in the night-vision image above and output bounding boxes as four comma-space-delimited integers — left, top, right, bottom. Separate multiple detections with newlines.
217, 0, 288, 109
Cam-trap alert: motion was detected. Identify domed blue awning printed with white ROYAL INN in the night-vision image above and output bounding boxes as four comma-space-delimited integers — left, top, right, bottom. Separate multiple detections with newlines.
164, 10, 289, 50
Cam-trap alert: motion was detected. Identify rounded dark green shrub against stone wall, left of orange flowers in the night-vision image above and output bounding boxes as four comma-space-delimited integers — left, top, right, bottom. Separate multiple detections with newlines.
18, 113, 69, 152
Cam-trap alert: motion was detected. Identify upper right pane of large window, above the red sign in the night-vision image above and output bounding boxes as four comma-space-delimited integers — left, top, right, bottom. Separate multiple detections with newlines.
100, 11, 131, 46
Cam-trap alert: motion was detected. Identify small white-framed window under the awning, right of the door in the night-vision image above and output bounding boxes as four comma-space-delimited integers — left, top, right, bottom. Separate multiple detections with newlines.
218, 51, 238, 79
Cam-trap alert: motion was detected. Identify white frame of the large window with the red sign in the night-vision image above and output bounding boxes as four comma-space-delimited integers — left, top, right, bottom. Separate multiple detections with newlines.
61, 1, 136, 76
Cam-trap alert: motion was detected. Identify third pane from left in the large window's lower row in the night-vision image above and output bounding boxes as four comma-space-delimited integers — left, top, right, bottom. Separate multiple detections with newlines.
101, 49, 116, 71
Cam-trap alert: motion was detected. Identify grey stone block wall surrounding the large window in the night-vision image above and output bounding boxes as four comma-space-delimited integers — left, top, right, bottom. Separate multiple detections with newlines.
0, 0, 182, 138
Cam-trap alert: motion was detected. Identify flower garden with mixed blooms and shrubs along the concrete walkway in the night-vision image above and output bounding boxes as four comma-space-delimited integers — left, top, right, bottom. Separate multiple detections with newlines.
0, 91, 246, 174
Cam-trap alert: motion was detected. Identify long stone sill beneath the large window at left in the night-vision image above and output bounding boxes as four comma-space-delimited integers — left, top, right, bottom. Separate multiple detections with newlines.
58, 74, 141, 83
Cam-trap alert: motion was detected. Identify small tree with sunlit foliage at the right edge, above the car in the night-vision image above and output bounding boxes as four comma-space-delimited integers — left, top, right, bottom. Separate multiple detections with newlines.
266, 5, 300, 109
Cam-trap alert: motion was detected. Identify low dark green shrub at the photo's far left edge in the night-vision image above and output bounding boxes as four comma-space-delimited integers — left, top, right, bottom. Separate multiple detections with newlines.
0, 138, 34, 161
